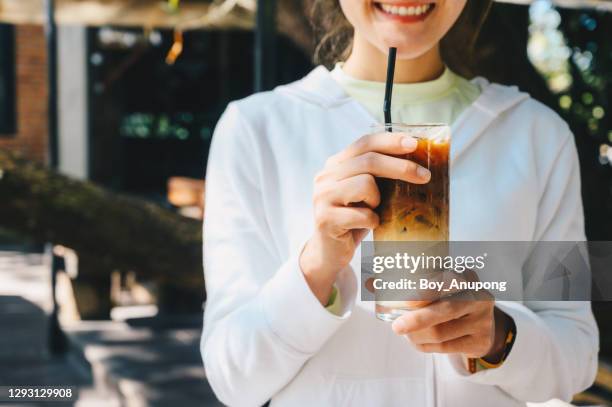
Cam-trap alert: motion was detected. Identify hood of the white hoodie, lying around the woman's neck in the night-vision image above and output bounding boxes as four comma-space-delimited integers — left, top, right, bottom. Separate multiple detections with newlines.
275, 66, 529, 159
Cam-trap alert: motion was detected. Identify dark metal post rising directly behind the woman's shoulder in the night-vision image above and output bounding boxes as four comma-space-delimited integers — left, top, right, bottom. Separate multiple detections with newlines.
255, 0, 276, 92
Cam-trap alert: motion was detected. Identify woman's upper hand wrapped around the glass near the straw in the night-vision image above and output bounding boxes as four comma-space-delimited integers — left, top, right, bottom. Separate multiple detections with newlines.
299, 133, 431, 306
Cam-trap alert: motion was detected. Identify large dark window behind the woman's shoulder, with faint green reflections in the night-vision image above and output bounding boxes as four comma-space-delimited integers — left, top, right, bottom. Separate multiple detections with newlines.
88, 27, 312, 204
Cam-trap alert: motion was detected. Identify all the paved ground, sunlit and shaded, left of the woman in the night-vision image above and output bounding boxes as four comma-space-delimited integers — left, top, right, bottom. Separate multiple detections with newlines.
0, 250, 220, 407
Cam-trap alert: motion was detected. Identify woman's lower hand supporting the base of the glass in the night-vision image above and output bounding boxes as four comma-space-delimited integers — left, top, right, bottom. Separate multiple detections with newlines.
393, 293, 511, 363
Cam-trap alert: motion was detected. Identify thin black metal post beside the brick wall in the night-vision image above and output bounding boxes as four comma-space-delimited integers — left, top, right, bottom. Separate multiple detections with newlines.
45, 0, 67, 354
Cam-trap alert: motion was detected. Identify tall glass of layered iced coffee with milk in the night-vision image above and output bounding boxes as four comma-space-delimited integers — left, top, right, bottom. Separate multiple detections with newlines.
374, 124, 450, 320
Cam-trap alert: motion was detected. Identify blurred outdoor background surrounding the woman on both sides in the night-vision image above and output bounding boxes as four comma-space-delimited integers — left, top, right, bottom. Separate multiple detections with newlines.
0, 0, 612, 406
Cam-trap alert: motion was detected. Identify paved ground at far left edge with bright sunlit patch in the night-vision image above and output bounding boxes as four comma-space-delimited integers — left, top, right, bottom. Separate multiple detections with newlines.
0, 251, 118, 407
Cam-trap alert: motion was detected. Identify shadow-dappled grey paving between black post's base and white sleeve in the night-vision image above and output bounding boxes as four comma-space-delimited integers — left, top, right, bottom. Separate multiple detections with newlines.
68, 316, 221, 406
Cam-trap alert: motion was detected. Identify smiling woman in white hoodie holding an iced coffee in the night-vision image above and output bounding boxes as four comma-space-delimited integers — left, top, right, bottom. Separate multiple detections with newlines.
202, 0, 598, 406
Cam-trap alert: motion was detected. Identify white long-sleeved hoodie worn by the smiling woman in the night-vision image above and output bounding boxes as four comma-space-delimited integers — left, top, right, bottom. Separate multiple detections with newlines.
202, 67, 598, 407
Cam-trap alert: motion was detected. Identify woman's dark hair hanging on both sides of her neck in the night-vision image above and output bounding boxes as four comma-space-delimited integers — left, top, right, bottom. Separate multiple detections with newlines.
311, 0, 493, 77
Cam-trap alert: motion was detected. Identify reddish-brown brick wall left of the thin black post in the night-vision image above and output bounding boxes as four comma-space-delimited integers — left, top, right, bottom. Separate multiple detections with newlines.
0, 25, 48, 162
